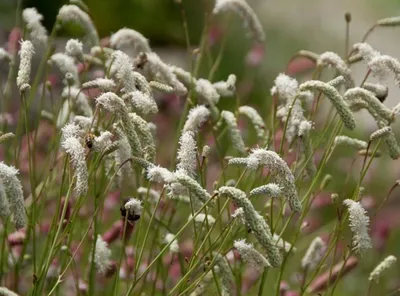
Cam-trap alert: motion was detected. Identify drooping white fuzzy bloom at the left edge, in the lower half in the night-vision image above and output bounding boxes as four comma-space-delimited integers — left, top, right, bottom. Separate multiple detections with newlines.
0, 162, 26, 230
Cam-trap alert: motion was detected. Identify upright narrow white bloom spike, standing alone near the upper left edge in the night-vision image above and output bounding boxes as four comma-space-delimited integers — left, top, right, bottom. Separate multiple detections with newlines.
17, 40, 35, 93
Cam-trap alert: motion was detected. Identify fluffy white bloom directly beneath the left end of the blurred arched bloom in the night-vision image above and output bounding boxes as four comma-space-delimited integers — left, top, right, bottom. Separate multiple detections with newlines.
111, 50, 137, 93
